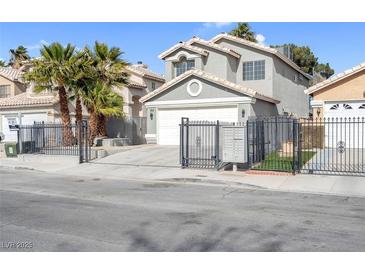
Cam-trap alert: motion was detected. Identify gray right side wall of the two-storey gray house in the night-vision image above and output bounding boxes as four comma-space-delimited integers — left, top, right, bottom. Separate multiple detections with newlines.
273, 58, 309, 117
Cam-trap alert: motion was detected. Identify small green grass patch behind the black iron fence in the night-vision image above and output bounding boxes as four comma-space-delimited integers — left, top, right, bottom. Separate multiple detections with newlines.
252, 151, 315, 172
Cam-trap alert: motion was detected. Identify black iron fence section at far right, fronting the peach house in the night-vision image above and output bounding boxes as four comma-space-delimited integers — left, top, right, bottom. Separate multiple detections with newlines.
300, 117, 365, 176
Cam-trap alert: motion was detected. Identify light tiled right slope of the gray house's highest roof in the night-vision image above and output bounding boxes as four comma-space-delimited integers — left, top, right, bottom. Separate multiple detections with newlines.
210, 33, 311, 79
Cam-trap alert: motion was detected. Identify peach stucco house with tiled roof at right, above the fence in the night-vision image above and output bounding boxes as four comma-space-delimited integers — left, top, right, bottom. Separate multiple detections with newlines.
305, 63, 365, 119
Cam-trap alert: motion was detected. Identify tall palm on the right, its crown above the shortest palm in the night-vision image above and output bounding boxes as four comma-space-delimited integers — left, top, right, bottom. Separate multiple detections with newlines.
85, 41, 129, 136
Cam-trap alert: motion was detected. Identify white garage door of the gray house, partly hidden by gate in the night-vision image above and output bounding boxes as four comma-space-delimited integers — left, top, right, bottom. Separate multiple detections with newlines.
157, 106, 238, 145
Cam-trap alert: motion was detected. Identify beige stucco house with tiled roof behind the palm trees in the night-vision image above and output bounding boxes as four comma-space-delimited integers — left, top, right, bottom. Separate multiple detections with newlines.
0, 64, 165, 141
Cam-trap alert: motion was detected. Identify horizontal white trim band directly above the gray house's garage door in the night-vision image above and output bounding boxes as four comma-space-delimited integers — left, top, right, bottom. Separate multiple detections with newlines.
145, 97, 256, 108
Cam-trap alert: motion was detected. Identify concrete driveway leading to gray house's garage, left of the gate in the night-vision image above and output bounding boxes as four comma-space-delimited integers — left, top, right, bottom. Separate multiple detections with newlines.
97, 145, 180, 167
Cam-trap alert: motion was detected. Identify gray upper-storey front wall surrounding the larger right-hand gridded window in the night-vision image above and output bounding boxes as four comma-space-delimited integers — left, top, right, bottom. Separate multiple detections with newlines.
213, 40, 273, 97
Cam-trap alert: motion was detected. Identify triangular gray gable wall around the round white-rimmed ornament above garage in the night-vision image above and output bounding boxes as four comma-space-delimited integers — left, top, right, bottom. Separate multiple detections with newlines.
150, 76, 247, 102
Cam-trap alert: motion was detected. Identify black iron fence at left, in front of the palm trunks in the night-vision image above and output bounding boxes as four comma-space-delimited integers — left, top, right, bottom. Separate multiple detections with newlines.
18, 121, 91, 163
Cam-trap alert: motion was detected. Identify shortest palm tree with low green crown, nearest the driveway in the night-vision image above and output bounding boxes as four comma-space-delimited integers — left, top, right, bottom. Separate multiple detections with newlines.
83, 81, 123, 144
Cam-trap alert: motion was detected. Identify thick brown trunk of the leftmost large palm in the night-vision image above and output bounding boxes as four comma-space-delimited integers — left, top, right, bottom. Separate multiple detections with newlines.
58, 86, 72, 146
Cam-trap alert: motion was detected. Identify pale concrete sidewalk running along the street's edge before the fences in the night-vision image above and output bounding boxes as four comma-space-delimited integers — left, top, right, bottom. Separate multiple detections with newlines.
0, 152, 365, 197
